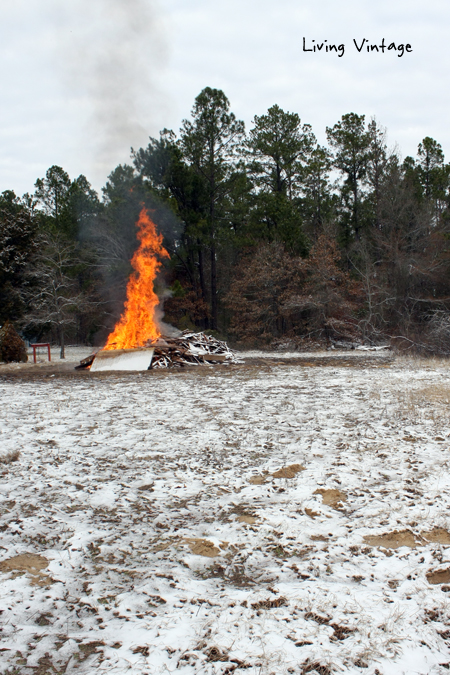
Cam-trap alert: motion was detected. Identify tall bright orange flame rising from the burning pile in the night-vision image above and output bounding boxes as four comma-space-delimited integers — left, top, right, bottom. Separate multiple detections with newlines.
104, 208, 169, 349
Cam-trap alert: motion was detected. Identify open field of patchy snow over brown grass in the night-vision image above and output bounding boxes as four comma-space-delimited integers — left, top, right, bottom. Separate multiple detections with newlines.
0, 354, 450, 675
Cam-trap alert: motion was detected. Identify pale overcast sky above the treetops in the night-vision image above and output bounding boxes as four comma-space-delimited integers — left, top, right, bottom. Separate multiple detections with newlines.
0, 0, 450, 194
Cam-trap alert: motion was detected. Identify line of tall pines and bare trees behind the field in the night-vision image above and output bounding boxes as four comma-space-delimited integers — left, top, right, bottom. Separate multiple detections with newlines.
0, 87, 450, 353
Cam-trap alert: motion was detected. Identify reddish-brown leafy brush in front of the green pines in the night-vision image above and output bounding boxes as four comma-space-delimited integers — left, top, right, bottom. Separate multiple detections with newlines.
225, 235, 362, 344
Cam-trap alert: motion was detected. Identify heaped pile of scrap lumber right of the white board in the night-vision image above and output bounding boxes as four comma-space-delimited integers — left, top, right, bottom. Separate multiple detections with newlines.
146, 330, 236, 370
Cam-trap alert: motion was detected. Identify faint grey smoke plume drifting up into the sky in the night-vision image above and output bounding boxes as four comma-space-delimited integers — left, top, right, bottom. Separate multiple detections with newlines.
58, 0, 166, 180
